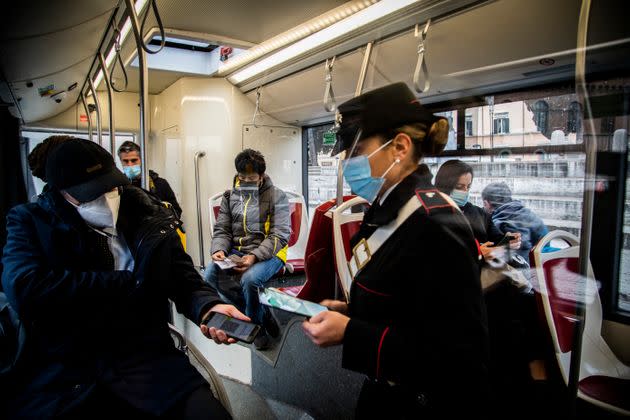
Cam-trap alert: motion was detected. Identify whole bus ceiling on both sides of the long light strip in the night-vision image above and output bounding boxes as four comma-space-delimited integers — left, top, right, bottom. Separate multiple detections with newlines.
0, 0, 629, 124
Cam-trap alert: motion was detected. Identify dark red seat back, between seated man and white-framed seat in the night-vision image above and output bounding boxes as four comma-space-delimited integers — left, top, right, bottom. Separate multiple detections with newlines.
280, 196, 362, 302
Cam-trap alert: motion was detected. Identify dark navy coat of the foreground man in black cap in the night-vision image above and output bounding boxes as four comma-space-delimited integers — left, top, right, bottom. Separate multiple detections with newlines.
2, 186, 220, 418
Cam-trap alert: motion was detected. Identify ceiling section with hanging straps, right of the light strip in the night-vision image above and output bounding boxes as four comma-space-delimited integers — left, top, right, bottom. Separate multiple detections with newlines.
247, 0, 628, 125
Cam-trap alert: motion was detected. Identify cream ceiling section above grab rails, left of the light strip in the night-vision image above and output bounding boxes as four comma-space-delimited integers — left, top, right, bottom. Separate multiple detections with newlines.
0, 0, 345, 123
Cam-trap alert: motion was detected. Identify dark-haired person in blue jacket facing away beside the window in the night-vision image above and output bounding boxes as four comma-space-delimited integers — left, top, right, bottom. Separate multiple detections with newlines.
481, 182, 549, 262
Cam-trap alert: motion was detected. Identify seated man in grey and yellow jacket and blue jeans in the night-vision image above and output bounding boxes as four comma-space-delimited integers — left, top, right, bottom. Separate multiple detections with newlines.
205, 149, 291, 349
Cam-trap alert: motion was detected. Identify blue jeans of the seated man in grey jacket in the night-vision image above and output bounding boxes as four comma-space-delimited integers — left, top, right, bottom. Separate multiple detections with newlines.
204, 257, 284, 324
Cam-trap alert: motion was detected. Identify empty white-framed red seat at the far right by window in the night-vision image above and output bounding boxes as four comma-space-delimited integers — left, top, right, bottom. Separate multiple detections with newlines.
530, 230, 630, 415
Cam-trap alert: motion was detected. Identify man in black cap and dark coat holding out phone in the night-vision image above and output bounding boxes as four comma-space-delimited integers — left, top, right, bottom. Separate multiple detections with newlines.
2, 139, 249, 418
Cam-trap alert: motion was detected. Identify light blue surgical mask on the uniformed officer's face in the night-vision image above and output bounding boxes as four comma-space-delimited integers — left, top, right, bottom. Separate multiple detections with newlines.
343, 140, 400, 203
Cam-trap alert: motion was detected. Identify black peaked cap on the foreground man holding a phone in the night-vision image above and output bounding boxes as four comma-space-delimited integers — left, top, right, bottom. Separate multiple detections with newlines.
46, 139, 129, 203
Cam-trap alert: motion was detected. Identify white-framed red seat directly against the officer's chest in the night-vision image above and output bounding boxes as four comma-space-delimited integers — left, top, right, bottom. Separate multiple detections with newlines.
332, 197, 368, 301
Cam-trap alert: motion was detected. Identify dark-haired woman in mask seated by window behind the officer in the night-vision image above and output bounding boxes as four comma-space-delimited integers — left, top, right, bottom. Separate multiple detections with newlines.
435, 160, 521, 260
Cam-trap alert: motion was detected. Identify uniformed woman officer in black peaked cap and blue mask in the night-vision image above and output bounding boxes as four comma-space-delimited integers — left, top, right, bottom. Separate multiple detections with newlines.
302, 83, 487, 418
